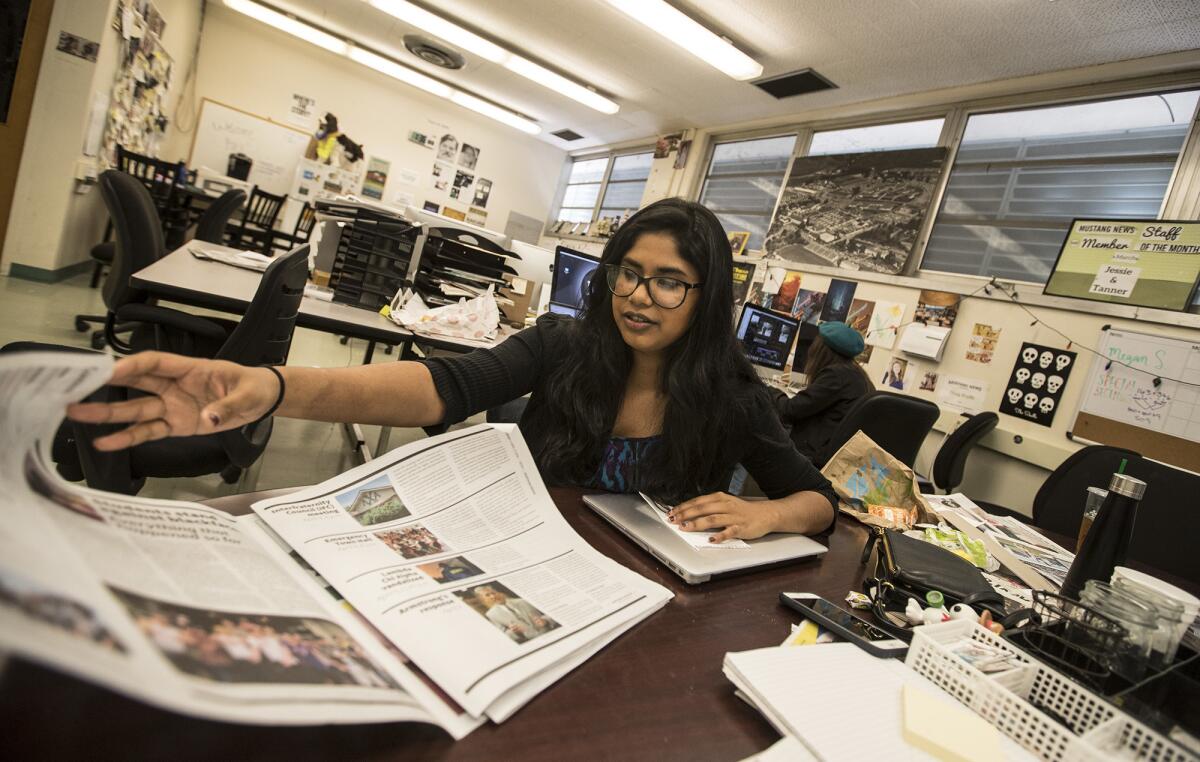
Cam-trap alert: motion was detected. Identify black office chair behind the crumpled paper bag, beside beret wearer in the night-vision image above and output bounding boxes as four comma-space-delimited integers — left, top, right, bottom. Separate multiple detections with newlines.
814, 391, 941, 468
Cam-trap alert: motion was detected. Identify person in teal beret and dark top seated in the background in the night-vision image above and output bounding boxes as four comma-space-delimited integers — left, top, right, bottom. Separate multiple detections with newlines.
775, 322, 875, 468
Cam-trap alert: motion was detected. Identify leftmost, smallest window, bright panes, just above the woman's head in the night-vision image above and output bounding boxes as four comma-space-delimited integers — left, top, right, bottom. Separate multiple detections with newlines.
556, 151, 654, 229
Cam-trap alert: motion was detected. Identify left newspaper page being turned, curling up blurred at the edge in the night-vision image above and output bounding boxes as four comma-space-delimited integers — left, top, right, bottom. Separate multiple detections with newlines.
0, 353, 478, 737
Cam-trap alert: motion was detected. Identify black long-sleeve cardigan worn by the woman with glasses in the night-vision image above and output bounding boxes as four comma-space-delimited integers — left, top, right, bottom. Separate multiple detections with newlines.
424, 318, 838, 518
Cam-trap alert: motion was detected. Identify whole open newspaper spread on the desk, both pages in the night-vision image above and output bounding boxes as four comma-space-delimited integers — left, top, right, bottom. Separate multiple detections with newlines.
0, 354, 671, 738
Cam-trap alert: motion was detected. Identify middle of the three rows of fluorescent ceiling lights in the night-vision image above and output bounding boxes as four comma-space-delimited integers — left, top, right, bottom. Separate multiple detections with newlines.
367, 0, 620, 114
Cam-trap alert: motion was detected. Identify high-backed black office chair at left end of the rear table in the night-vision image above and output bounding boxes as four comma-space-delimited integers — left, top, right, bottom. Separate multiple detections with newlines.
80, 169, 234, 356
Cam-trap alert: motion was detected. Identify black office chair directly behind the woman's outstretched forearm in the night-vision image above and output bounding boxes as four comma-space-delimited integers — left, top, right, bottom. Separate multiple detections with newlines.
31, 246, 308, 494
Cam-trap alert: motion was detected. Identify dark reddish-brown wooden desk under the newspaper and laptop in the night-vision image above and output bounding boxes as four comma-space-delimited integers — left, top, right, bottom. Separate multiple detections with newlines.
0, 490, 869, 761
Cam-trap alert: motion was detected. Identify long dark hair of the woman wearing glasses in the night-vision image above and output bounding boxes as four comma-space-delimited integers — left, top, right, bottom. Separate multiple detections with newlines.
530, 198, 766, 500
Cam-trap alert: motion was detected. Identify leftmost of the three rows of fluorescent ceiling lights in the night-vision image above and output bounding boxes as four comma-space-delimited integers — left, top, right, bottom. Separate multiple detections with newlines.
224, 0, 542, 134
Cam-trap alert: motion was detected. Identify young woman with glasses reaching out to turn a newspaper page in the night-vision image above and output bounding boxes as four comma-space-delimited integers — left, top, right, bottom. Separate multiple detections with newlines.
68, 199, 836, 541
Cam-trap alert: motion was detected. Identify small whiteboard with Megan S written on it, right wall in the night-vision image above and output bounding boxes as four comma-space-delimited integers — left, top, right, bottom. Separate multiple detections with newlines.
1072, 330, 1200, 470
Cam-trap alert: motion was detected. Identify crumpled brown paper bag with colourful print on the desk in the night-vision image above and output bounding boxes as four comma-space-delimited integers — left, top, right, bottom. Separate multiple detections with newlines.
821, 432, 937, 529
